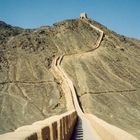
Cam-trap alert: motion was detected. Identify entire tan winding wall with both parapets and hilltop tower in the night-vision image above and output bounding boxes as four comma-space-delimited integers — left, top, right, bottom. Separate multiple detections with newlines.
0, 13, 136, 140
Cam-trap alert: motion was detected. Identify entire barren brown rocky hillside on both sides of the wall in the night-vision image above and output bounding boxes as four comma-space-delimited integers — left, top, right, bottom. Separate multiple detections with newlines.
0, 19, 140, 138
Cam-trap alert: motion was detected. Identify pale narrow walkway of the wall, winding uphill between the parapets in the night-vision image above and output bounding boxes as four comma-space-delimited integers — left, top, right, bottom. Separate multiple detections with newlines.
53, 20, 103, 140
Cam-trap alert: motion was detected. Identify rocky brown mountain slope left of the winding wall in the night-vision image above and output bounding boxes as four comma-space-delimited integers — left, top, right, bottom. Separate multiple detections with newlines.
0, 19, 99, 133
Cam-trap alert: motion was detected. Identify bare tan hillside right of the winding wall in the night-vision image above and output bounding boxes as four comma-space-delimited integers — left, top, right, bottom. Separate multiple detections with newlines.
62, 19, 140, 138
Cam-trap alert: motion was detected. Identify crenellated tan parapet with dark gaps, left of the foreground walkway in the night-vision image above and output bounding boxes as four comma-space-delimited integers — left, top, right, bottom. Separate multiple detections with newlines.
0, 110, 77, 140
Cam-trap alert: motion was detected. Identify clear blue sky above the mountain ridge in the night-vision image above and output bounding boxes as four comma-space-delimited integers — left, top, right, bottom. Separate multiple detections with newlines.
0, 0, 140, 39
